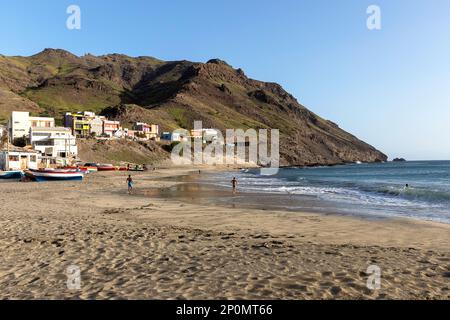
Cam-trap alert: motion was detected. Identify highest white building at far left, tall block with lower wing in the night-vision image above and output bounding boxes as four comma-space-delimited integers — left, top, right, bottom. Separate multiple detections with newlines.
8, 111, 55, 143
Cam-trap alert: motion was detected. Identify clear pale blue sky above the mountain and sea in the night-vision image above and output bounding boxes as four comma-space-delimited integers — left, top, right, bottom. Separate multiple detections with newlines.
0, 0, 450, 160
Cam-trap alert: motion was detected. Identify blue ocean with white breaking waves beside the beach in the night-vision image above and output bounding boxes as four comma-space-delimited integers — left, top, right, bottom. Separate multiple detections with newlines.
204, 161, 450, 223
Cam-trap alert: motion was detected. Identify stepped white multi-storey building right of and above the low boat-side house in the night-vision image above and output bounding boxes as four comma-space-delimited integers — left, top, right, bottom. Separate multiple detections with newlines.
30, 127, 78, 158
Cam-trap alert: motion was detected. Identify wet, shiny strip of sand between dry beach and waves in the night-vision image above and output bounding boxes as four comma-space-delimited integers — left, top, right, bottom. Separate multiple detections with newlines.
151, 168, 450, 225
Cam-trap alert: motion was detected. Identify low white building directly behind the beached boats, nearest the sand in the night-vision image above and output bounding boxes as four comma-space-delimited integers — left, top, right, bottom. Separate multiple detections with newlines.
0, 149, 39, 171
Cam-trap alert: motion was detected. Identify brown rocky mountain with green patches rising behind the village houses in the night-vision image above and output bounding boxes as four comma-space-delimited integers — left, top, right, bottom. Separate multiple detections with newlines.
0, 49, 387, 165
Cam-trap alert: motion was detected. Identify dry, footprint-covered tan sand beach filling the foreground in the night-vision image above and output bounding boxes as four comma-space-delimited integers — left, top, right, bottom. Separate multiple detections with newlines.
0, 168, 450, 299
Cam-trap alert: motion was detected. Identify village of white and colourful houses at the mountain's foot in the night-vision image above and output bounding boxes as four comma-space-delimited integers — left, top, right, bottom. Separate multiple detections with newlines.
0, 111, 218, 171
